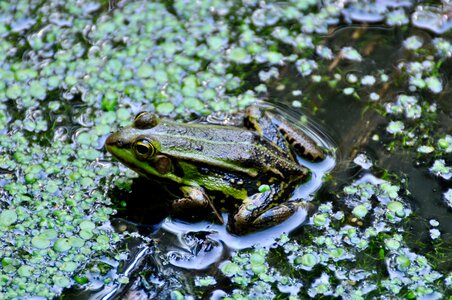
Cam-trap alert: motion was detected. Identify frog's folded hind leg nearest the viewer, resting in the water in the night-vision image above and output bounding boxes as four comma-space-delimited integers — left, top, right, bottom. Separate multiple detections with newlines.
228, 189, 312, 234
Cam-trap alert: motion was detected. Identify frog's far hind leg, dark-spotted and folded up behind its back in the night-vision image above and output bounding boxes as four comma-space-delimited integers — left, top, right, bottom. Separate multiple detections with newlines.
245, 106, 325, 161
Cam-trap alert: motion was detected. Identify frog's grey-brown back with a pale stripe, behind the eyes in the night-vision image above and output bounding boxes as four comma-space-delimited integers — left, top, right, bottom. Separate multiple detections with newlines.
150, 121, 308, 178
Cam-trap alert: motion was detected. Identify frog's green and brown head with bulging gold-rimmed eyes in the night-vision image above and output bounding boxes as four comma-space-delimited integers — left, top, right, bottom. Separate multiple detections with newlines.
105, 112, 177, 177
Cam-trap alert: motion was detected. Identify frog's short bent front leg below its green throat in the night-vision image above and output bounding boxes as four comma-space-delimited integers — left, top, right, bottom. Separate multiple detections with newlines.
172, 186, 224, 224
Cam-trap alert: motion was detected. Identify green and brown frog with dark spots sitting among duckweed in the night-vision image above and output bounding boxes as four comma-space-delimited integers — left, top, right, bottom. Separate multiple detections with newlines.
105, 105, 325, 234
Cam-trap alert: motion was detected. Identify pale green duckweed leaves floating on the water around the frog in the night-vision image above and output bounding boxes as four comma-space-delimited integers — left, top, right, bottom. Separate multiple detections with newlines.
0, 0, 452, 299
